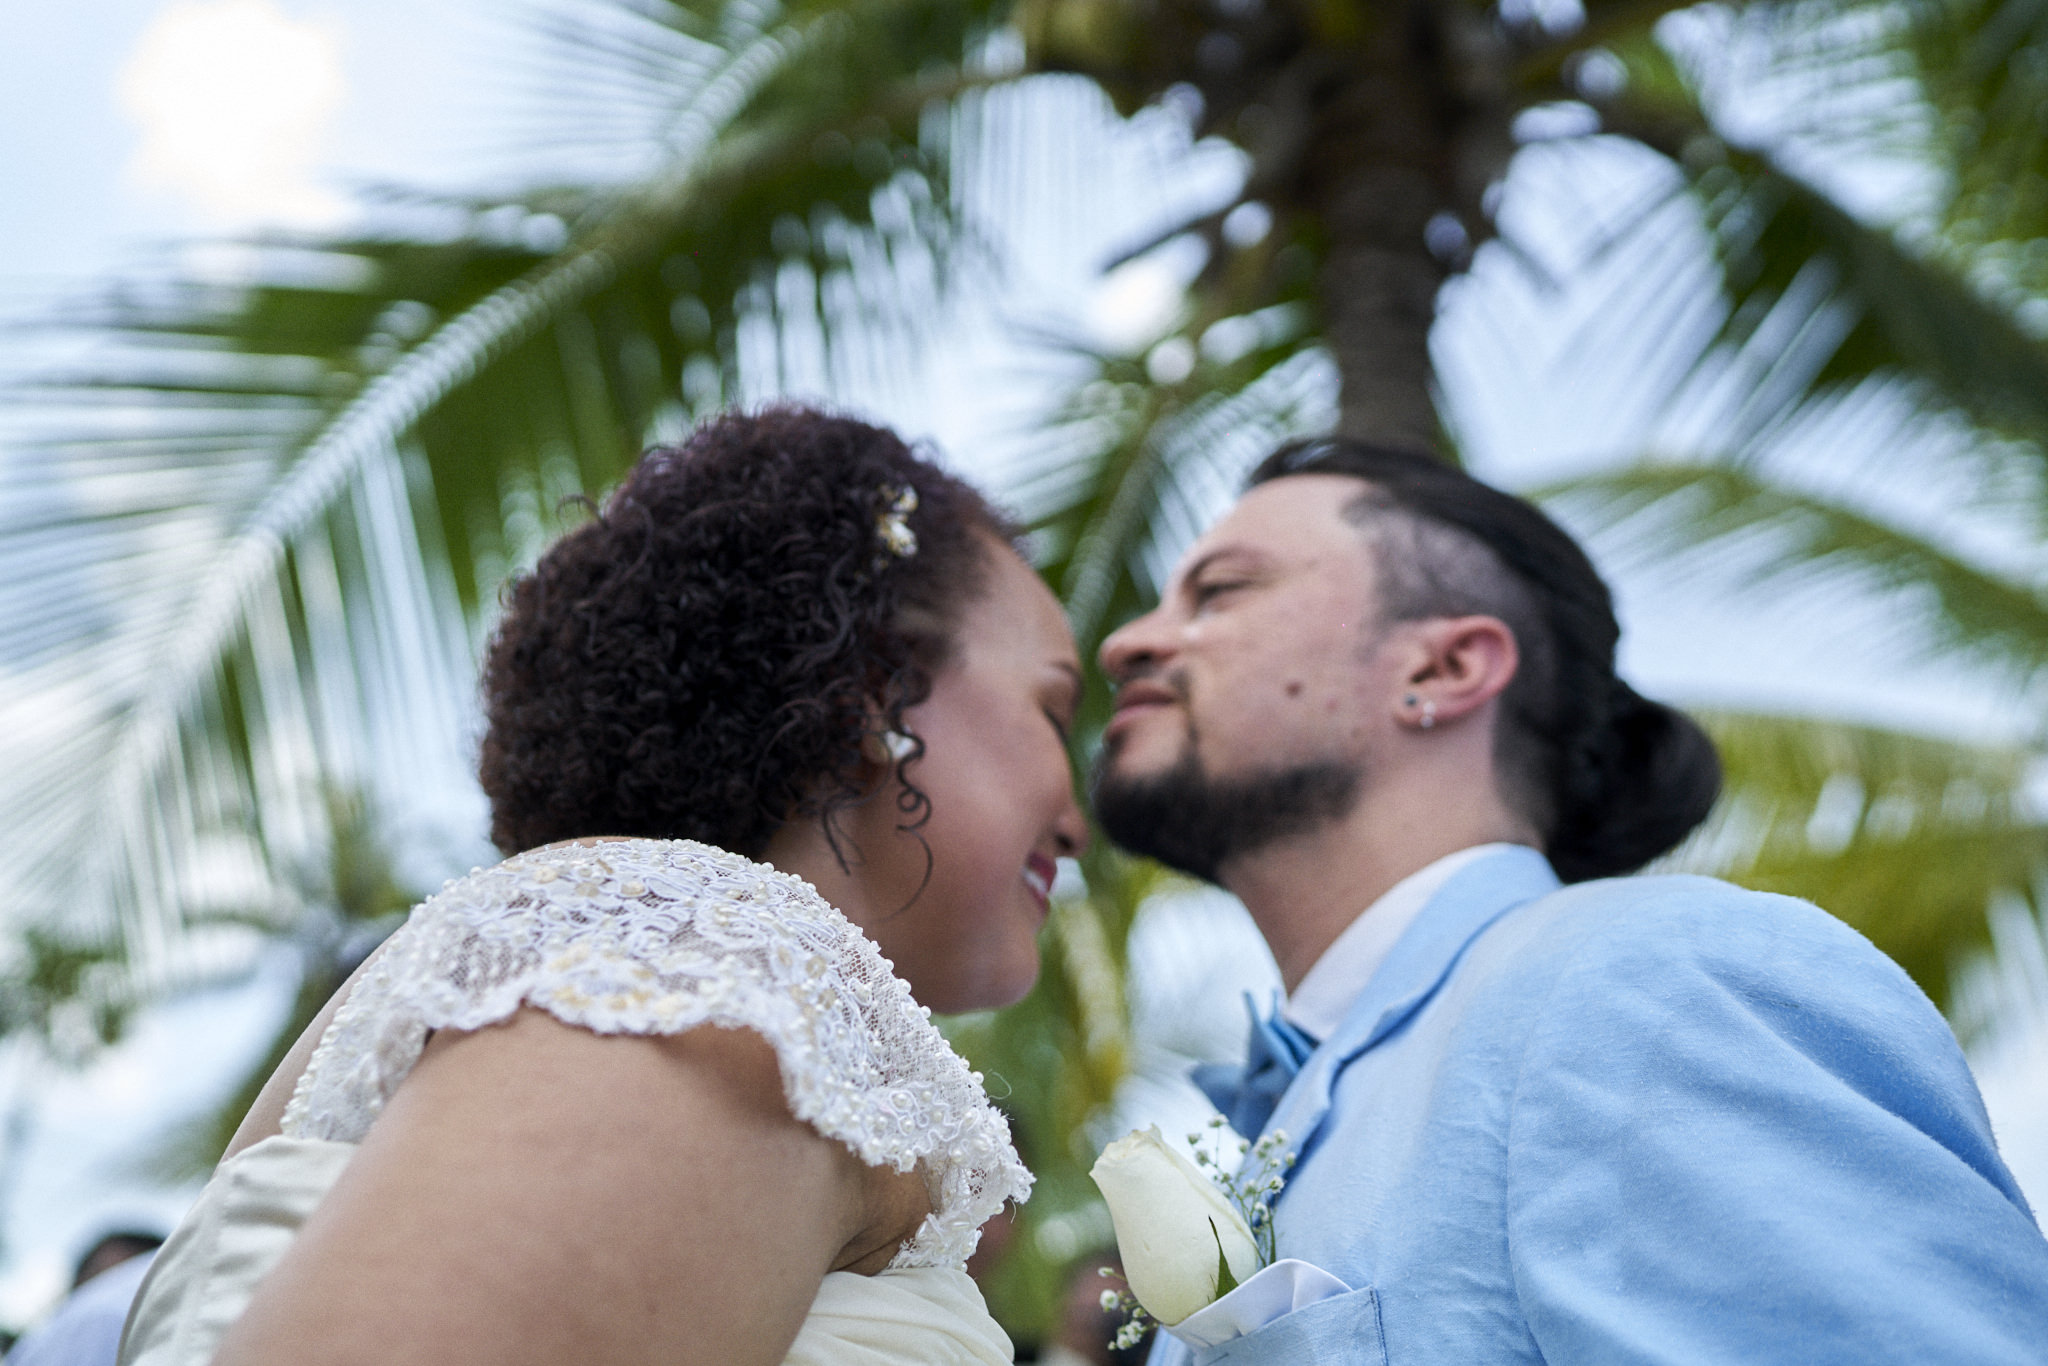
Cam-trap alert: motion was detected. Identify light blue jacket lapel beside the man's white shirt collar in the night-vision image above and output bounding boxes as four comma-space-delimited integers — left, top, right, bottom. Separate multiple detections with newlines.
1266, 846, 1561, 1153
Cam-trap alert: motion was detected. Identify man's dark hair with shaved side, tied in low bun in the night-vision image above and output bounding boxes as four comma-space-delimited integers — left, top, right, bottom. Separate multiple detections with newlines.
1249, 438, 1720, 883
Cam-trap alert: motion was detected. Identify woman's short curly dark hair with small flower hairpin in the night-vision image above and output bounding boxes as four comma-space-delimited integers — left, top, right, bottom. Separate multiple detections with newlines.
479, 408, 1016, 856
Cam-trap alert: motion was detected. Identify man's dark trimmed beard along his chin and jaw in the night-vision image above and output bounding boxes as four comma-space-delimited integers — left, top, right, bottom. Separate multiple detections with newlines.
1094, 735, 1358, 883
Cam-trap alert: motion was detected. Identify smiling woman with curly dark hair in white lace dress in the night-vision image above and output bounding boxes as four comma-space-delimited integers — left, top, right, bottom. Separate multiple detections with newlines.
121, 408, 1083, 1366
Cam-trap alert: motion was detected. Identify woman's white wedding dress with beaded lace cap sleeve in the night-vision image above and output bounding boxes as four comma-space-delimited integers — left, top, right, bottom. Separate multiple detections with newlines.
121, 840, 1030, 1366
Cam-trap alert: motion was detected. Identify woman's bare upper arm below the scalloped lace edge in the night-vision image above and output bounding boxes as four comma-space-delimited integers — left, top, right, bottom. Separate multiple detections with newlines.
217, 1008, 901, 1366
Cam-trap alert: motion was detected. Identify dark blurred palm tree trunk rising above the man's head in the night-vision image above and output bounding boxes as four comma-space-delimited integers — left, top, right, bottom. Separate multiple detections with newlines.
1182, 0, 1511, 453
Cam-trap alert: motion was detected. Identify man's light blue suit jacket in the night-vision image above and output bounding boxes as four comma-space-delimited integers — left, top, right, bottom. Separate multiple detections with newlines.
1151, 850, 2048, 1366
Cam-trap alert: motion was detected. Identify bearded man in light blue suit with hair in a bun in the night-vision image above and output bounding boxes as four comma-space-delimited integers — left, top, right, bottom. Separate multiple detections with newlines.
1096, 440, 2048, 1366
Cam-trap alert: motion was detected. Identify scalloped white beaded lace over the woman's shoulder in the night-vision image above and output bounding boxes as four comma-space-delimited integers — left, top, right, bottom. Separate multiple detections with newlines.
283, 840, 1030, 1268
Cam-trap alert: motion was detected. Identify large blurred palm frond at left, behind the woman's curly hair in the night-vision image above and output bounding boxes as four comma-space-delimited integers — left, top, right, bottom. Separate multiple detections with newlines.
0, 0, 999, 995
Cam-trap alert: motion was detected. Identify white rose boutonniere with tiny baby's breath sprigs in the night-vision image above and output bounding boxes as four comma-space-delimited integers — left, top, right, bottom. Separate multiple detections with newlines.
1090, 1118, 1292, 1343
